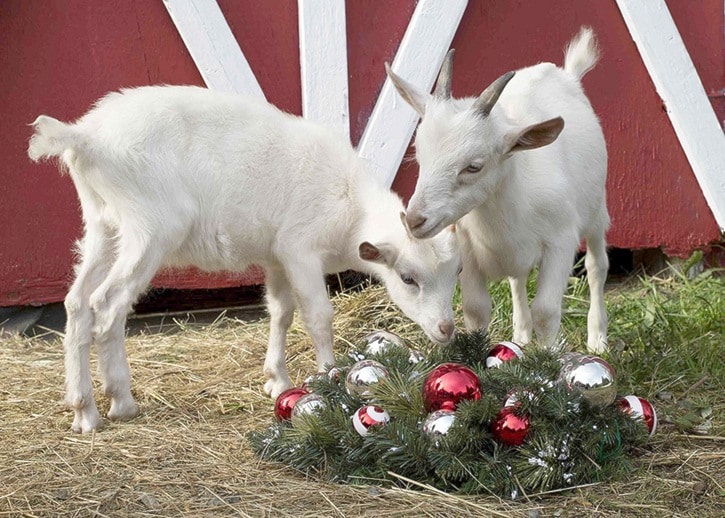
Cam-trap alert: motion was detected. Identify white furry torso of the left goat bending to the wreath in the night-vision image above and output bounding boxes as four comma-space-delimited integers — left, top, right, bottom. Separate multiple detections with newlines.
57, 86, 359, 270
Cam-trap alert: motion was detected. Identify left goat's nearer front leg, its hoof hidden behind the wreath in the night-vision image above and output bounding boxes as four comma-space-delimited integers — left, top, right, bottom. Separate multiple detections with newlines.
285, 255, 335, 372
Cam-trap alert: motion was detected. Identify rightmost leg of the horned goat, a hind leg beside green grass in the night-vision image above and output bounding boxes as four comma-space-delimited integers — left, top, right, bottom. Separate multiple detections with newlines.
584, 233, 609, 353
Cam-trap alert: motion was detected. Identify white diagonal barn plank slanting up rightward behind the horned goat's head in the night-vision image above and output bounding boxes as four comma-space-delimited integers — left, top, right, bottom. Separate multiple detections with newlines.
358, 0, 468, 186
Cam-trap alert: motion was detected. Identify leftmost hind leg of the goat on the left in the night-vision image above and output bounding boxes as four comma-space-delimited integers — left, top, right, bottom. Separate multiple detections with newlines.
63, 220, 113, 433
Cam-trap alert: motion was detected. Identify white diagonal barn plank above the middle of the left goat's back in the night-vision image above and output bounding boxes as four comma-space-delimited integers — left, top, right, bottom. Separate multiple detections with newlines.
164, 0, 265, 99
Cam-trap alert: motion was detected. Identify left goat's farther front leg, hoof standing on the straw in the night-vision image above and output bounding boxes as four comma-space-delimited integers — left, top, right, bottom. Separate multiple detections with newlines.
264, 268, 295, 398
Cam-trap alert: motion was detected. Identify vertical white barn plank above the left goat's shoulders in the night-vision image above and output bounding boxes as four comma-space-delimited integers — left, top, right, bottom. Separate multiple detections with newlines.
297, 0, 350, 137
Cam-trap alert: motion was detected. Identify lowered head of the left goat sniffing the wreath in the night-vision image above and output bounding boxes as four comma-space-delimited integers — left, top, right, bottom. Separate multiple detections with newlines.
358, 212, 461, 343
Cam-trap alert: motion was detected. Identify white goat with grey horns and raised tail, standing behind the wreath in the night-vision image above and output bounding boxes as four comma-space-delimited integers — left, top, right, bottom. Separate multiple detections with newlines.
388, 27, 609, 352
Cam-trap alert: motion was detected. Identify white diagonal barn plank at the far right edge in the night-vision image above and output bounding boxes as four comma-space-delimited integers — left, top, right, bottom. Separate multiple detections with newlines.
617, 0, 725, 231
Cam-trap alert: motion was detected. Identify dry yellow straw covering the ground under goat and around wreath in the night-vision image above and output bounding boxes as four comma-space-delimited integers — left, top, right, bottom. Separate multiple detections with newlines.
0, 288, 725, 517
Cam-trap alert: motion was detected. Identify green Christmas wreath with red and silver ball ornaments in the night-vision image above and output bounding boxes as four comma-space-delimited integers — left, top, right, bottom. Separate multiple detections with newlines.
249, 331, 657, 498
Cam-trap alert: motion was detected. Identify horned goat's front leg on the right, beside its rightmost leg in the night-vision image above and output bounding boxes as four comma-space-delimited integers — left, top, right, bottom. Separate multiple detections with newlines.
531, 246, 576, 348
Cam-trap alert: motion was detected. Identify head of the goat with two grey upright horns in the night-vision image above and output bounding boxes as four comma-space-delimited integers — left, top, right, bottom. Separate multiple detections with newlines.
386, 49, 564, 238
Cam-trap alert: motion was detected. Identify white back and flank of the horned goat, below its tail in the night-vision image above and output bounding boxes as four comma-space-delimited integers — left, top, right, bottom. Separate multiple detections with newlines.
497, 63, 608, 235
